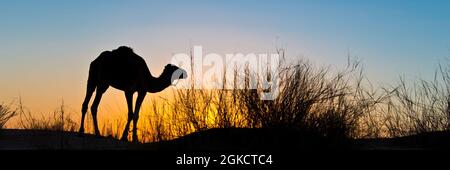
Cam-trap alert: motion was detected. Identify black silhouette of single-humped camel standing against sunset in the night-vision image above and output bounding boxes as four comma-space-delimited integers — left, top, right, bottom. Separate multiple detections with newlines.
79, 46, 187, 142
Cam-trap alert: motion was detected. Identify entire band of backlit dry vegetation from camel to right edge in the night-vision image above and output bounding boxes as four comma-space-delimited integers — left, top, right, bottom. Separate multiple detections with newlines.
139, 51, 450, 141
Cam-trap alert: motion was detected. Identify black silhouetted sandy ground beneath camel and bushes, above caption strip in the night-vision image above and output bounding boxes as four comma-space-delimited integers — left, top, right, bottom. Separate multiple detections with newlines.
0, 129, 450, 151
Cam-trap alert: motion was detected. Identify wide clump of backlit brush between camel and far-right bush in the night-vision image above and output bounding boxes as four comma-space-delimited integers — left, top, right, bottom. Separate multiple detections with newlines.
146, 50, 385, 139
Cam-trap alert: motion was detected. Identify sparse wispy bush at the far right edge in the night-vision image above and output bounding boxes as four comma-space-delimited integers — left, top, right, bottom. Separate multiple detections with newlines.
382, 63, 450, 137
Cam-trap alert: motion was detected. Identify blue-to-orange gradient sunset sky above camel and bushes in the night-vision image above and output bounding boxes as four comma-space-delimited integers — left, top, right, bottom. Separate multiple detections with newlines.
0, 0, 450, 118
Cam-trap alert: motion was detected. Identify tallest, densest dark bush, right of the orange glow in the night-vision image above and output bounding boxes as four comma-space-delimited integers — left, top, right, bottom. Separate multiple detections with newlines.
239, 55, 384, 139
